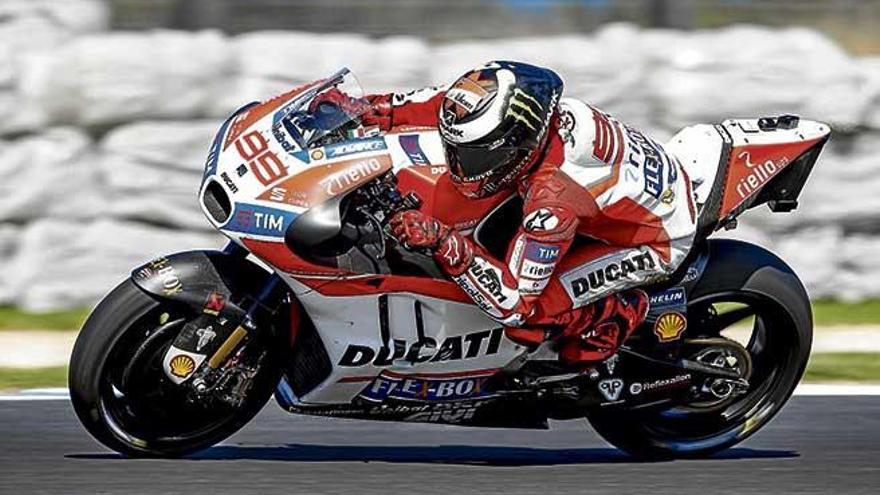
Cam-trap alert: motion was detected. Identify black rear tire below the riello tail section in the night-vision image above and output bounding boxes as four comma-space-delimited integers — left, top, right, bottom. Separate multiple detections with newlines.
587, 240, 813, 459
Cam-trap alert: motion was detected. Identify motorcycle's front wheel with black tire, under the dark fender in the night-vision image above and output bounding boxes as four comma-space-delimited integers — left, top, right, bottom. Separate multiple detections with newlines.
68, 280, 281, 457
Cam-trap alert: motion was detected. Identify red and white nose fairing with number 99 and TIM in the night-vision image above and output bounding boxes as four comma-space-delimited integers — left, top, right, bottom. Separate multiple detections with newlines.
200, 70, 445, 275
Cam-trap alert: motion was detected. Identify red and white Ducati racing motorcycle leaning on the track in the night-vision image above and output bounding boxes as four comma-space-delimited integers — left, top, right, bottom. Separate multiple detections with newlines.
69, 70, 830, 458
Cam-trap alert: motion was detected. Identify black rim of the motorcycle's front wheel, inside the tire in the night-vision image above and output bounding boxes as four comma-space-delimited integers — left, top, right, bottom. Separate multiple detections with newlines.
98, 307, 244, 451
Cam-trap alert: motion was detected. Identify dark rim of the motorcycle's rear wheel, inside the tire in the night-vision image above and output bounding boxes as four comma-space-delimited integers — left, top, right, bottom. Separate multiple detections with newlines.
639, 292, 802, 452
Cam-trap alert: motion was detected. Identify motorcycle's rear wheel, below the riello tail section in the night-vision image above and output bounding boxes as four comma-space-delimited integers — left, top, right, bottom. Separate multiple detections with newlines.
588, 243, 812, 458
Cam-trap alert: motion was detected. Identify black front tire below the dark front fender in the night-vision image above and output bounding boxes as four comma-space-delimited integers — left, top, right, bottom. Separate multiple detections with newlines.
68, 279, 281, 457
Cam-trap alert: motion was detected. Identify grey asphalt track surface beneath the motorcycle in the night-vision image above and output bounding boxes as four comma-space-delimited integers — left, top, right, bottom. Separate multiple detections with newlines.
0, 397, 880, 495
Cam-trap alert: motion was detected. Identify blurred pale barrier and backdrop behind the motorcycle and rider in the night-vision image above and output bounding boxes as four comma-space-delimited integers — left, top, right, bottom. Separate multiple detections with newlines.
0, 0, 880, 318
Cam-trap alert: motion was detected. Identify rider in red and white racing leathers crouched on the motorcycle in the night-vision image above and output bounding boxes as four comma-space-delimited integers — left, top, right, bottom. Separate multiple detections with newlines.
326, 61, 696, 369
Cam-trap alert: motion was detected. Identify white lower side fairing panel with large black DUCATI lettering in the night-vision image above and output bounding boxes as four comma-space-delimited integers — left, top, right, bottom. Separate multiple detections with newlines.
285, 277, 526, 405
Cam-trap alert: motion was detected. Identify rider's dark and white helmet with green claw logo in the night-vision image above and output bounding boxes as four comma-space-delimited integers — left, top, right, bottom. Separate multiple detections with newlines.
440, 61, 562, 198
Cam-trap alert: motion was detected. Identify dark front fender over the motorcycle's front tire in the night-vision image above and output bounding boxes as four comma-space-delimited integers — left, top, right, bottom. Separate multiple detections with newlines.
131, 251, 272, 313
